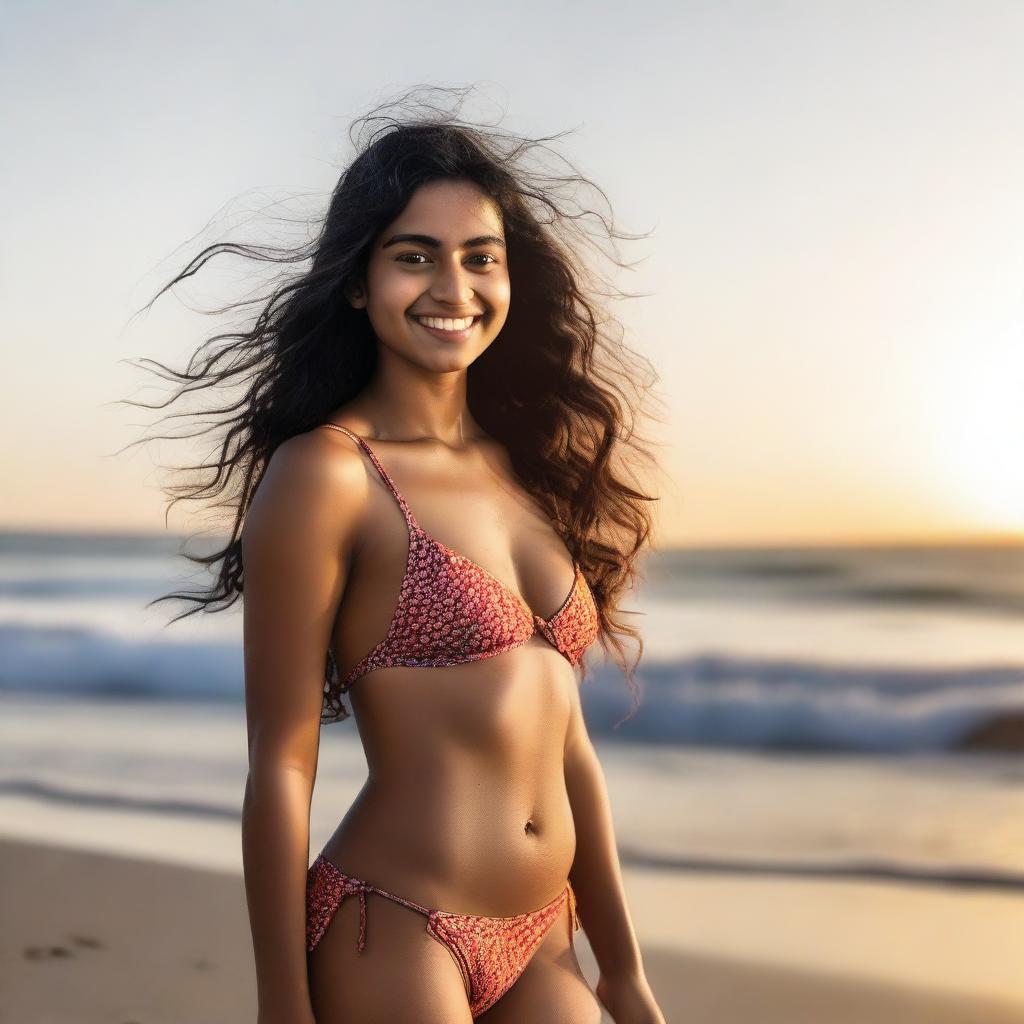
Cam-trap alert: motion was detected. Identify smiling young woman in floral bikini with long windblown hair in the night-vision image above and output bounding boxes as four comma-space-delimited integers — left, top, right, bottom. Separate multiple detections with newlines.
136, 90, 664, 1024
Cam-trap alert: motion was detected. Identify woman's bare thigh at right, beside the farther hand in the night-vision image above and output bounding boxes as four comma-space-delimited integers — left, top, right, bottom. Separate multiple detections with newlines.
476, 905, 601, 1024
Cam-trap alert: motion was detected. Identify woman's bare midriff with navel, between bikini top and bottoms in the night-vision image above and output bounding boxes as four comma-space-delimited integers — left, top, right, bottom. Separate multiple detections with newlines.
325, 638, 578, 916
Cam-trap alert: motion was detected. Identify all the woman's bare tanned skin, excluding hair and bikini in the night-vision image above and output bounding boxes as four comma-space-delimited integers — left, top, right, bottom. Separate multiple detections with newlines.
242, 181, 665, 1024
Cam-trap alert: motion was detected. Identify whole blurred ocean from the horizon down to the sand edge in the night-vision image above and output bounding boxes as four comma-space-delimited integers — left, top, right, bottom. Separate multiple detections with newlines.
0, 532, 1024, 891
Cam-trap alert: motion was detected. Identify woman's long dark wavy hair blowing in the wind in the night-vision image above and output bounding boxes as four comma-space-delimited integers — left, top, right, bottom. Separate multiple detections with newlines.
121, 89, 657, 723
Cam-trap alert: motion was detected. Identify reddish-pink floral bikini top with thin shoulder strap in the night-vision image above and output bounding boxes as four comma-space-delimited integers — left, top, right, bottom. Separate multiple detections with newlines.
323, 423, 599, 692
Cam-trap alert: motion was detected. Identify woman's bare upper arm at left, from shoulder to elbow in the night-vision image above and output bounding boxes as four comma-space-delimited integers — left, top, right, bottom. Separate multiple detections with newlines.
242, 431, 369, 778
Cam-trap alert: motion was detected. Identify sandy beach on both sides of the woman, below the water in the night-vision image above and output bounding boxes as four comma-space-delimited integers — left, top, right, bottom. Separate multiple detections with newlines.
0, 840, 1024, 1024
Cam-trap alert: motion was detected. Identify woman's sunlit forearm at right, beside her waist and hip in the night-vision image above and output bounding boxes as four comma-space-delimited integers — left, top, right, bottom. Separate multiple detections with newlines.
565, 739, 643, 977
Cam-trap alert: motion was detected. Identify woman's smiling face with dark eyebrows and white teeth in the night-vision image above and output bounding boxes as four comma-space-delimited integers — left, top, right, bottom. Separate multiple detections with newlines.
348, 181, 511, 372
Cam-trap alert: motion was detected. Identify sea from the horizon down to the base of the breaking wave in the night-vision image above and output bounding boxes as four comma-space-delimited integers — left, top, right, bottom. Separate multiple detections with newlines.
0, 532, 1024, 753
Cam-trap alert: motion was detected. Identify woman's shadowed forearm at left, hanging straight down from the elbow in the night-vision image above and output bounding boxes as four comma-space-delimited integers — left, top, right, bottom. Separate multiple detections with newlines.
242, 765, 312, 1021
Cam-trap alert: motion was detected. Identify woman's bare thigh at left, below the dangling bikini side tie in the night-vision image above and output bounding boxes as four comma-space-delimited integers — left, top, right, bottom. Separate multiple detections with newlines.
308, 893, 472, 1024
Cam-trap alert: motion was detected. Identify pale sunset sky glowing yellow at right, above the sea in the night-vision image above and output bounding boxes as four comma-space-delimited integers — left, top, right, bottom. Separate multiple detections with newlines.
0, 0, 1024, 546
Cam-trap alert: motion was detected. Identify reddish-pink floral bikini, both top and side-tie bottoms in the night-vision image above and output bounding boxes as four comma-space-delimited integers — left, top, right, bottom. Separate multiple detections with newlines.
306, 423, 599, 1019
